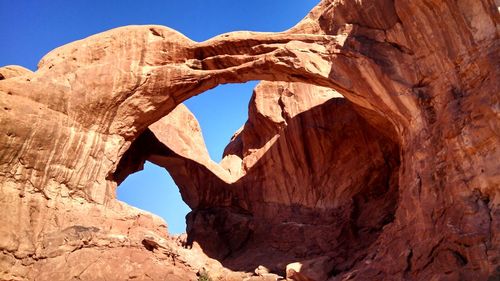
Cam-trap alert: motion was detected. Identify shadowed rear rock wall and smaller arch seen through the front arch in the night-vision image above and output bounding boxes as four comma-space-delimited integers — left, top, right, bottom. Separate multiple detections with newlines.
139, 80, 399, 273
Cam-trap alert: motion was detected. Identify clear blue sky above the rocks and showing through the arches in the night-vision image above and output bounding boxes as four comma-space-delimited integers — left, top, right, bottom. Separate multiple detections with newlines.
0, 0, 319, 233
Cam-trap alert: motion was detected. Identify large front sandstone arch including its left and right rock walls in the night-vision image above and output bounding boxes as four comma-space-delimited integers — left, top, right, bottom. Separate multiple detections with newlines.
0, 0, 500, 279
